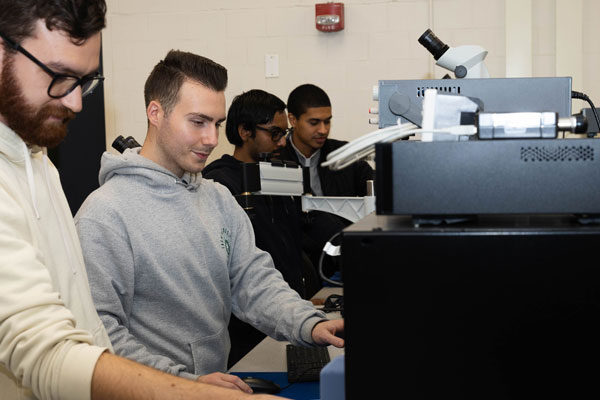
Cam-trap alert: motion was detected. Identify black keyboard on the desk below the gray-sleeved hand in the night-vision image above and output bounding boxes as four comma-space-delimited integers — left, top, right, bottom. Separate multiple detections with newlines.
286, 344, 330, 383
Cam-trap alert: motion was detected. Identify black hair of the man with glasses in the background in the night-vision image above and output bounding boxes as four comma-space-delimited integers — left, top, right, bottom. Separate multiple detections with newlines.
225, 89, 285, 147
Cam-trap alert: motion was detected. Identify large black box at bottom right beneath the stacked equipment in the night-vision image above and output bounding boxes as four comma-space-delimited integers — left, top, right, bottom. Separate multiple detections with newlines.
342, 214, 600, 400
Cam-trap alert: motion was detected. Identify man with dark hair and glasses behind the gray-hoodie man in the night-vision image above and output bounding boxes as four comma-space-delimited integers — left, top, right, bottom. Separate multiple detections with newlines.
202, 89, 319, 365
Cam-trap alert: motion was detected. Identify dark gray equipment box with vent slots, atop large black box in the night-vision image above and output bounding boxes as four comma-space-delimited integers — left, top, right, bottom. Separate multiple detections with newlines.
375, 139, 600, 218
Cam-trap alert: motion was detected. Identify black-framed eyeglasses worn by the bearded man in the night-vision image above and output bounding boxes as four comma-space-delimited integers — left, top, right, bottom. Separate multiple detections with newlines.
0, 32, 104, 99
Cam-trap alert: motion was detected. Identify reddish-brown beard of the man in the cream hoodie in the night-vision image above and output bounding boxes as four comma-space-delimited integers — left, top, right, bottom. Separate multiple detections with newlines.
0, 52, 75, 148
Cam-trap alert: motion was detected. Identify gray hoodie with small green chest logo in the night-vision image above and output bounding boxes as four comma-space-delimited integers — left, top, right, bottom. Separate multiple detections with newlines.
75, 148, 326, 378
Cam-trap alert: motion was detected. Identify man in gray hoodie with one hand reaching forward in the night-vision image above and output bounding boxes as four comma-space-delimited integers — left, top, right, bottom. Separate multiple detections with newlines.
76, 51, 344, 384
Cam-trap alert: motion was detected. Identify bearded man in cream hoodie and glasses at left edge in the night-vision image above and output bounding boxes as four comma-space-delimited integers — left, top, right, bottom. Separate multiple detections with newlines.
0, 0, 280, 400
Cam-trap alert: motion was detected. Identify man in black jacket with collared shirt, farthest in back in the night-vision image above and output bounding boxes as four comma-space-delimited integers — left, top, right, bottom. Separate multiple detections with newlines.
280, 84, 373, 275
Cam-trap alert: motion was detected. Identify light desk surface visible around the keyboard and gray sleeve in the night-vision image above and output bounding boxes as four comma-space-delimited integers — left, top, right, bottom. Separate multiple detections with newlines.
229, 287, 344, 372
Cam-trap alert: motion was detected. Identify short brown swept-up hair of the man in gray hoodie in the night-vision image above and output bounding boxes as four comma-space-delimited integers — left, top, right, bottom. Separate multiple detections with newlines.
144, 50, 227, 114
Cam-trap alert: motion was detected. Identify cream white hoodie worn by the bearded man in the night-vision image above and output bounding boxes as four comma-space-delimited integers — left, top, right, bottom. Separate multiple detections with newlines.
0, 123, 112, 400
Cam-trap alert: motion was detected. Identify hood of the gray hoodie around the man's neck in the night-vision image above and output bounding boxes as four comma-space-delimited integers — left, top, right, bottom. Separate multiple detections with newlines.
98, 147, 202, 191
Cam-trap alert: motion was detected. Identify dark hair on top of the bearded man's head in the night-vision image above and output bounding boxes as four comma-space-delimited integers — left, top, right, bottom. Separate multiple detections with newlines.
0, 0, 106, 47
